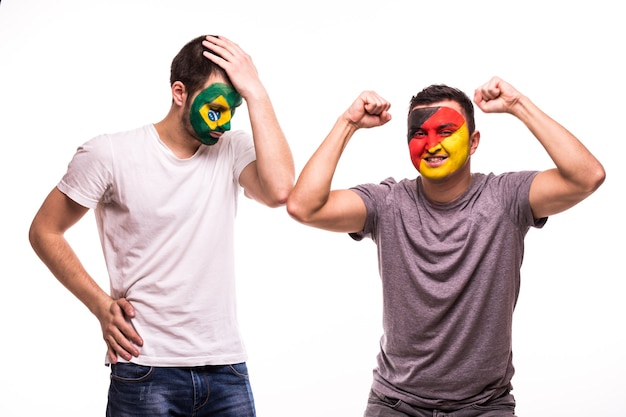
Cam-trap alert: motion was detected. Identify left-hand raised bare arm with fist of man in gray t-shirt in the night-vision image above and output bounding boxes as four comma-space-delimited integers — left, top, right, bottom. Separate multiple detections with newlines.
287, 91, 391, 232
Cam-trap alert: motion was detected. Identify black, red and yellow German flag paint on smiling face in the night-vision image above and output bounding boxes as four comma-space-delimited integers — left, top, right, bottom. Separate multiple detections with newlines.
407, 106, 470, 180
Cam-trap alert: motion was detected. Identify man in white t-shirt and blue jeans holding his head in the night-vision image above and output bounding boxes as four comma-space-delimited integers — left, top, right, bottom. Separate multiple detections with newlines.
29, 36, 295, 417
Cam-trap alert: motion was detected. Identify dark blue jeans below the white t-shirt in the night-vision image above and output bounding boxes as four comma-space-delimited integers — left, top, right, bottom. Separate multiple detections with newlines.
106, 363, 256, 417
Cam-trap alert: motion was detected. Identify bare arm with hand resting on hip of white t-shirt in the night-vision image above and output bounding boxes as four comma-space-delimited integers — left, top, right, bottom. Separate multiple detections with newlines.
29, 188, 143, 363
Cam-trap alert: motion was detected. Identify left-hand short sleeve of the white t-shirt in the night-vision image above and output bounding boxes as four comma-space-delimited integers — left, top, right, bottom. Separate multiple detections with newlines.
57, 135, 112, 209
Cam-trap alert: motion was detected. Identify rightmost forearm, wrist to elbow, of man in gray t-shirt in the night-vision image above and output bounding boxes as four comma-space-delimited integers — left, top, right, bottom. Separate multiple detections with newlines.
511, 96, 604, 192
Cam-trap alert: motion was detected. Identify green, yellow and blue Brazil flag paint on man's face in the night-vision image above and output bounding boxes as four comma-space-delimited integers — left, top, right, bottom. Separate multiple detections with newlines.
189, 83, 242, 145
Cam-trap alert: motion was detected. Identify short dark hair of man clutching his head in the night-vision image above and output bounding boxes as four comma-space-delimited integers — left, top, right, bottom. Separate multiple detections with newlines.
170, 35, 231, 96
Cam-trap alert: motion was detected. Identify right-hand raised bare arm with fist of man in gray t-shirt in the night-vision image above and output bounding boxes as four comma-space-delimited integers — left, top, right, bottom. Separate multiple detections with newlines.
474, 77, 606, 218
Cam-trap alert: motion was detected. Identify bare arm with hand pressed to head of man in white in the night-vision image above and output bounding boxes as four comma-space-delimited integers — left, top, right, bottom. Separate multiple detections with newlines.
204, 36, 295, 207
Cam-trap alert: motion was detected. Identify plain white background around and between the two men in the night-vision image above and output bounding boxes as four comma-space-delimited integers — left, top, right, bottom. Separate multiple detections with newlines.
0, 0, 626, 417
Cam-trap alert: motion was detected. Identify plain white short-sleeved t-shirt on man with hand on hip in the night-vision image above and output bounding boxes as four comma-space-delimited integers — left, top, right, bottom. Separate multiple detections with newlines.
58, 124, 256, 366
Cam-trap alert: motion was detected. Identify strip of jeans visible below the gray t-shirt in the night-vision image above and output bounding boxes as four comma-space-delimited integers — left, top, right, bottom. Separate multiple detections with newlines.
363, 390, 515, 417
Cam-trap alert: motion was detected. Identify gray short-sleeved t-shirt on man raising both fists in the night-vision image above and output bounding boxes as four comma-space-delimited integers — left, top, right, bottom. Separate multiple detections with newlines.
351, 171, 547, 410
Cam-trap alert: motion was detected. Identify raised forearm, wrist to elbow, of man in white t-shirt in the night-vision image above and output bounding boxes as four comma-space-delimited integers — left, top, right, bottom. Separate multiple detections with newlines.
246, 89, 295, 205
